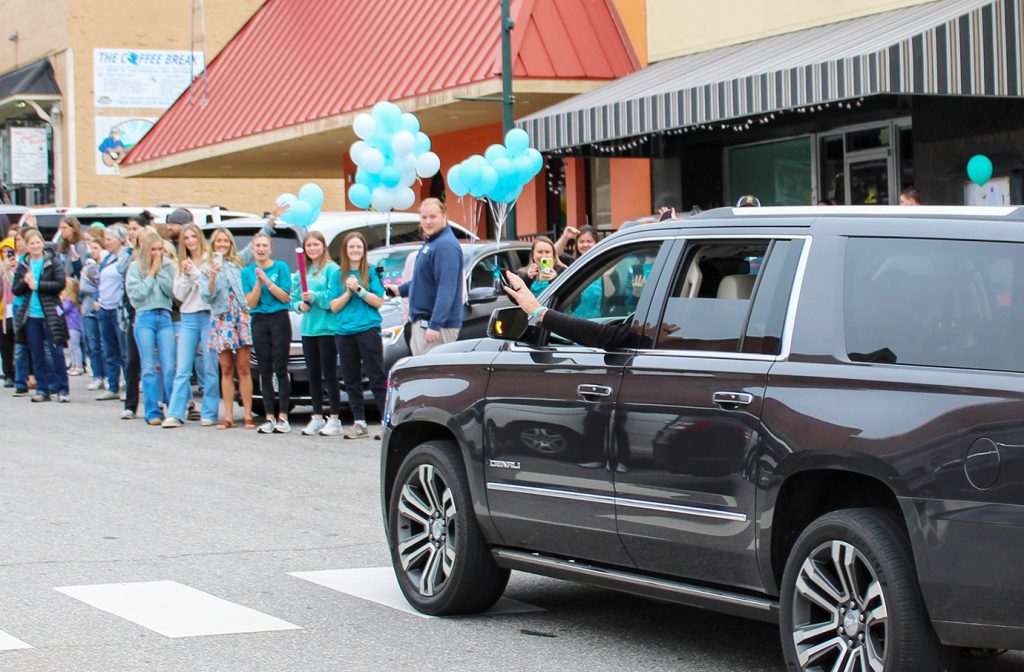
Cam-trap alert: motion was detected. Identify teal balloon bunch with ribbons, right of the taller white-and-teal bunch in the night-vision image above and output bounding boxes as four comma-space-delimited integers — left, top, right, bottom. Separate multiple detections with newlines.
447, 128, 544, 240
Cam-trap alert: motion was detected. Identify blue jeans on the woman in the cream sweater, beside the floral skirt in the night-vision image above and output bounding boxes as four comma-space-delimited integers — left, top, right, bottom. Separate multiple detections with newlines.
166, 310, 220, 421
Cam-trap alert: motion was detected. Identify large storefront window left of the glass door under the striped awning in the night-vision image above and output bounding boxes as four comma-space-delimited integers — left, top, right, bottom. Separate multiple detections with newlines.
727, 135, 813, 206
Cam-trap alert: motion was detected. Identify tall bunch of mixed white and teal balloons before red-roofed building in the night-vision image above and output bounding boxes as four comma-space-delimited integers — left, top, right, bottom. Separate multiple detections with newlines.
348, 101, 441, 212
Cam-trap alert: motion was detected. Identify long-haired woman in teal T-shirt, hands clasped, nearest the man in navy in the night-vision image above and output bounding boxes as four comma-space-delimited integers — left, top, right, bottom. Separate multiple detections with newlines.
331, 232, 387, 438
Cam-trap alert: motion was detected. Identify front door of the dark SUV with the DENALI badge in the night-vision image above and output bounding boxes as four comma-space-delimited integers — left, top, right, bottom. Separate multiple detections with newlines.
483, 242, 668, 566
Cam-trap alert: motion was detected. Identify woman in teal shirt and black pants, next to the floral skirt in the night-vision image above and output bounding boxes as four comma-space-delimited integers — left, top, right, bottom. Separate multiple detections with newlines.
242, 233, 292, 434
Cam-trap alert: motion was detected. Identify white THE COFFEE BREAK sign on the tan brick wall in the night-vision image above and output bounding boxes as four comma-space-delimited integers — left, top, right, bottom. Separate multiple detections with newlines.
92, 49, 204, 110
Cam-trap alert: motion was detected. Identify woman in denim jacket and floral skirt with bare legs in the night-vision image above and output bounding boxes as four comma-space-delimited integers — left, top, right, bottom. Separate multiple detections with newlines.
200, 228, 256, 429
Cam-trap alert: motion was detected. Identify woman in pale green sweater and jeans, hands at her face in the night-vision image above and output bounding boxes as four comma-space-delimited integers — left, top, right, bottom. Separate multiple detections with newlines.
125, 233, 176, 427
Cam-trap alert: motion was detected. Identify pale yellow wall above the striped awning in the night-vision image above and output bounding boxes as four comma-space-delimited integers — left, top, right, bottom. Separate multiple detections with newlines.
647, 0, 932, 62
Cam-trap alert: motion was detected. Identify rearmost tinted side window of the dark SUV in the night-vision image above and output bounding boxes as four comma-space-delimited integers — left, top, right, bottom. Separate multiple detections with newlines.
844, 239, 1024, 371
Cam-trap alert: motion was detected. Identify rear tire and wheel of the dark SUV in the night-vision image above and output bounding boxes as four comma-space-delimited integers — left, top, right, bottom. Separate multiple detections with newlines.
779, 508, 956, 672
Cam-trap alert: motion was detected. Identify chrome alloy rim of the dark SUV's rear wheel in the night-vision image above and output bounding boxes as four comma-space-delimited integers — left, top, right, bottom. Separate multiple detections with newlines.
793, 540, 888, 672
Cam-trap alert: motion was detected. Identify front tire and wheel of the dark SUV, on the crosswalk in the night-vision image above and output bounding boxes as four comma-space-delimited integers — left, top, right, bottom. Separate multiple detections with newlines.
388, 440, 509, 616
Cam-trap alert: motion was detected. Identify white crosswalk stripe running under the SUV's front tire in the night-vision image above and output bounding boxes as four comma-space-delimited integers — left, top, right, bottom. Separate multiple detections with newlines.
289, 566, 545, 619
